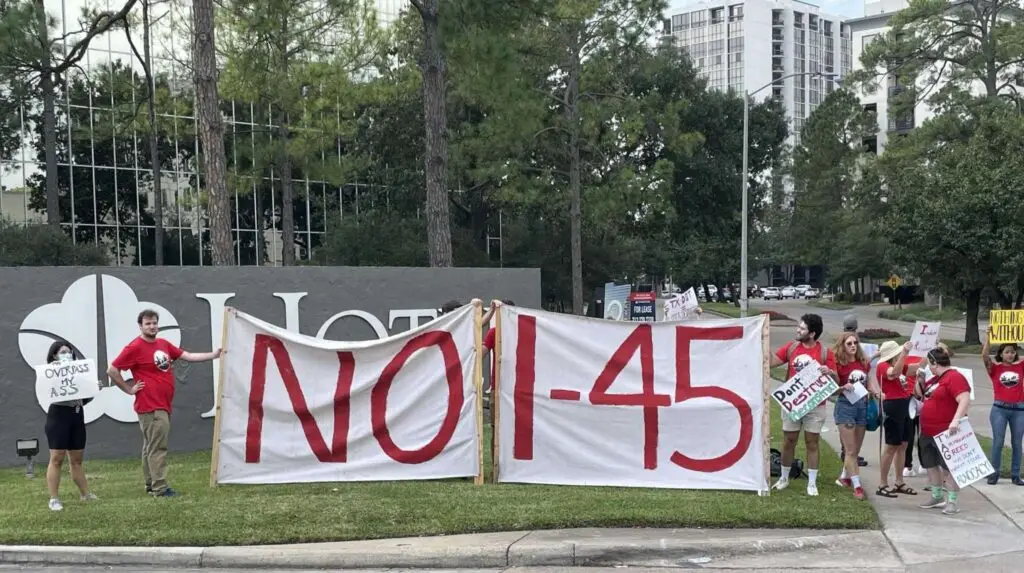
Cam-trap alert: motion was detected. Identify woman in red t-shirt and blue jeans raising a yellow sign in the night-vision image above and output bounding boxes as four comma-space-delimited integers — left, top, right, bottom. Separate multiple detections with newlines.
981, 326, 1024, 485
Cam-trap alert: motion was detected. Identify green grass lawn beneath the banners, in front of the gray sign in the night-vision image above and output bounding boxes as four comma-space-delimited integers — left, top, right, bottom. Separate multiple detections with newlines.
0, 406, 880, 545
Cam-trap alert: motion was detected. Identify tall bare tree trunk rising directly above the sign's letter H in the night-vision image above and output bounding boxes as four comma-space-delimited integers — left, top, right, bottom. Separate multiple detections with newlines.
193, 0, 234, 266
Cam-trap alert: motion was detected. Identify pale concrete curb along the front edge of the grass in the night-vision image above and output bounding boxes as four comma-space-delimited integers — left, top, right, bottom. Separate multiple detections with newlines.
0, 530, 887, 569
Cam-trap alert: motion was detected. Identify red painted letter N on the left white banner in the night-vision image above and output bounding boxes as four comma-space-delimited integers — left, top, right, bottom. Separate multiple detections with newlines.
246, 335, 355, 464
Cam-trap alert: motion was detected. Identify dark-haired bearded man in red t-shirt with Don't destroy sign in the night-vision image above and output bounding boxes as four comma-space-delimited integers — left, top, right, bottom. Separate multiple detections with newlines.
771, 314, 837, 495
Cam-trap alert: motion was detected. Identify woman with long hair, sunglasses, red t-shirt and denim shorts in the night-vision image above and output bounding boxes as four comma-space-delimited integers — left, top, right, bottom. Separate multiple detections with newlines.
833, 333, 881, 500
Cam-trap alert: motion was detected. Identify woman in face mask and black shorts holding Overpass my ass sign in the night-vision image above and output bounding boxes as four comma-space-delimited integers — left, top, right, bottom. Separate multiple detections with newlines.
46, 340, 99, 512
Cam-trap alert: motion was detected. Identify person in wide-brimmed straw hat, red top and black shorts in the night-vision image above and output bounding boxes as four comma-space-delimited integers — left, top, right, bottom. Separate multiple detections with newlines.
876, 341, 920, 497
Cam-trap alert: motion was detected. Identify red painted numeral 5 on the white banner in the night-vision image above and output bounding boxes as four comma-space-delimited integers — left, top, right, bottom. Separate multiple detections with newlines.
671, 326, 754, 473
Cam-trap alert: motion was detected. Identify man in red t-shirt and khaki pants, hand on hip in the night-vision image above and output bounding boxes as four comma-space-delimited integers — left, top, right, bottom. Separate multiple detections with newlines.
106, 309, 222, 497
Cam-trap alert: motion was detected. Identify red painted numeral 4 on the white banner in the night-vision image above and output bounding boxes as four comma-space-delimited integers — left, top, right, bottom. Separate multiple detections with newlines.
590, 324, 672, 470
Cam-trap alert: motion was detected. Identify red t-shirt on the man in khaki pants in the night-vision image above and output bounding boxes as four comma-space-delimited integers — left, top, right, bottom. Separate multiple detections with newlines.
112, 337, 183, 413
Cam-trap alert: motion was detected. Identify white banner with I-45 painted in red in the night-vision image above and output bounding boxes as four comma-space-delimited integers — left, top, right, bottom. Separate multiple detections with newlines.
496, 306, 768, 491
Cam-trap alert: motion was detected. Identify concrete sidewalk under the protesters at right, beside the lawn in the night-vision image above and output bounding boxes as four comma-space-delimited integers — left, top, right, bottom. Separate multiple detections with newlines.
819, 407, 1024, 571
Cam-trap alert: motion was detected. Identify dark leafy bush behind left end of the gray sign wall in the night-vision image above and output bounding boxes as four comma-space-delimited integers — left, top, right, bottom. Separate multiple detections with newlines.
0, 220, 111, 267
